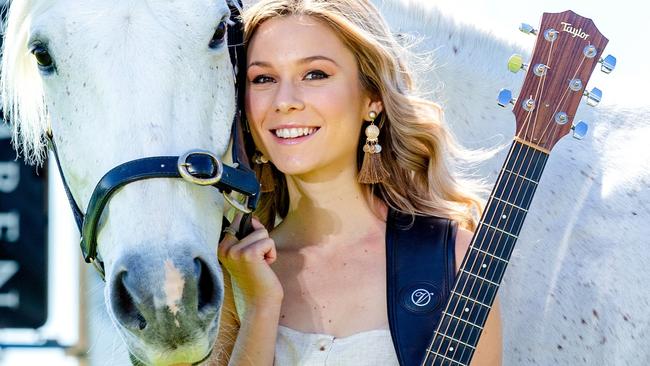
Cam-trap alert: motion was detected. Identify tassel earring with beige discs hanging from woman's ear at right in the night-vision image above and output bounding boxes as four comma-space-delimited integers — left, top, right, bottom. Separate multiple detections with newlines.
357, 111, 390, 184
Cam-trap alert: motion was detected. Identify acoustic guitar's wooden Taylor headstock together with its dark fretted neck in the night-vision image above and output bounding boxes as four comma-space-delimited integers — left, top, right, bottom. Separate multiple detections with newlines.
422, 11, 616, 366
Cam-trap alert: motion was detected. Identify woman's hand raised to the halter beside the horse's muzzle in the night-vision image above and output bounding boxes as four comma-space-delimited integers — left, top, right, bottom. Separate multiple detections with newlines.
217, 216, 284, 312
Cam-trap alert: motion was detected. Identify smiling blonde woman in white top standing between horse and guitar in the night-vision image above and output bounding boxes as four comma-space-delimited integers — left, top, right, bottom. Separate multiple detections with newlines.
215, 0, 502, 366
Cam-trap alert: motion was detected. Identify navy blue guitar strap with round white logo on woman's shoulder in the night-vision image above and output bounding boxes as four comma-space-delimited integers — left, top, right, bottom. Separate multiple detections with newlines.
386, 210, 457, 366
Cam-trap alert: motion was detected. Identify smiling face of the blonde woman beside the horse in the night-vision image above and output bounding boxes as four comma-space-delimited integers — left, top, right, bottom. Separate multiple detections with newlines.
246, 16, 381, 180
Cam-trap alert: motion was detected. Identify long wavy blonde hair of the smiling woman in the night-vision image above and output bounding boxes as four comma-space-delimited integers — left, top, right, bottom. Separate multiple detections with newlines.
242, 0, 483, 230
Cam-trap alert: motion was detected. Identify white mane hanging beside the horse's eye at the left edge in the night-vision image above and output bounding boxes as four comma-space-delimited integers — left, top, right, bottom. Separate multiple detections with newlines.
0, 0, 54, 165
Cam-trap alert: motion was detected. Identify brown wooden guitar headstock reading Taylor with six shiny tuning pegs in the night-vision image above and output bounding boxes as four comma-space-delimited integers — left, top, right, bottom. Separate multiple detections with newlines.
499, 10, 616, 151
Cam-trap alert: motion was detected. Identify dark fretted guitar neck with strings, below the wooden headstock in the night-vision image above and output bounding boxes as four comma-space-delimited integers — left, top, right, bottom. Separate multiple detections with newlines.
423, 140, 548, 366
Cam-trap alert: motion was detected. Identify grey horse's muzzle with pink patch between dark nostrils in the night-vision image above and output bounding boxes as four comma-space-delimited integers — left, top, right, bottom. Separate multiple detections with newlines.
108, 246, 223, 351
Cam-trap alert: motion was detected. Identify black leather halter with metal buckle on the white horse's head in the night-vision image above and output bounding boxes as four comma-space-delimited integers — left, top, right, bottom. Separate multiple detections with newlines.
46, 0, 260, 279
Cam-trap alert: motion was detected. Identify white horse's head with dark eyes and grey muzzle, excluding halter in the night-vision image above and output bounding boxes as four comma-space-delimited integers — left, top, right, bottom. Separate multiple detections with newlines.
2, 0, 240, 364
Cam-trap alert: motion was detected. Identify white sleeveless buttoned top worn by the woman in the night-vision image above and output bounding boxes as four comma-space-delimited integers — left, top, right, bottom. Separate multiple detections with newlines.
274, 325, 399, 366
